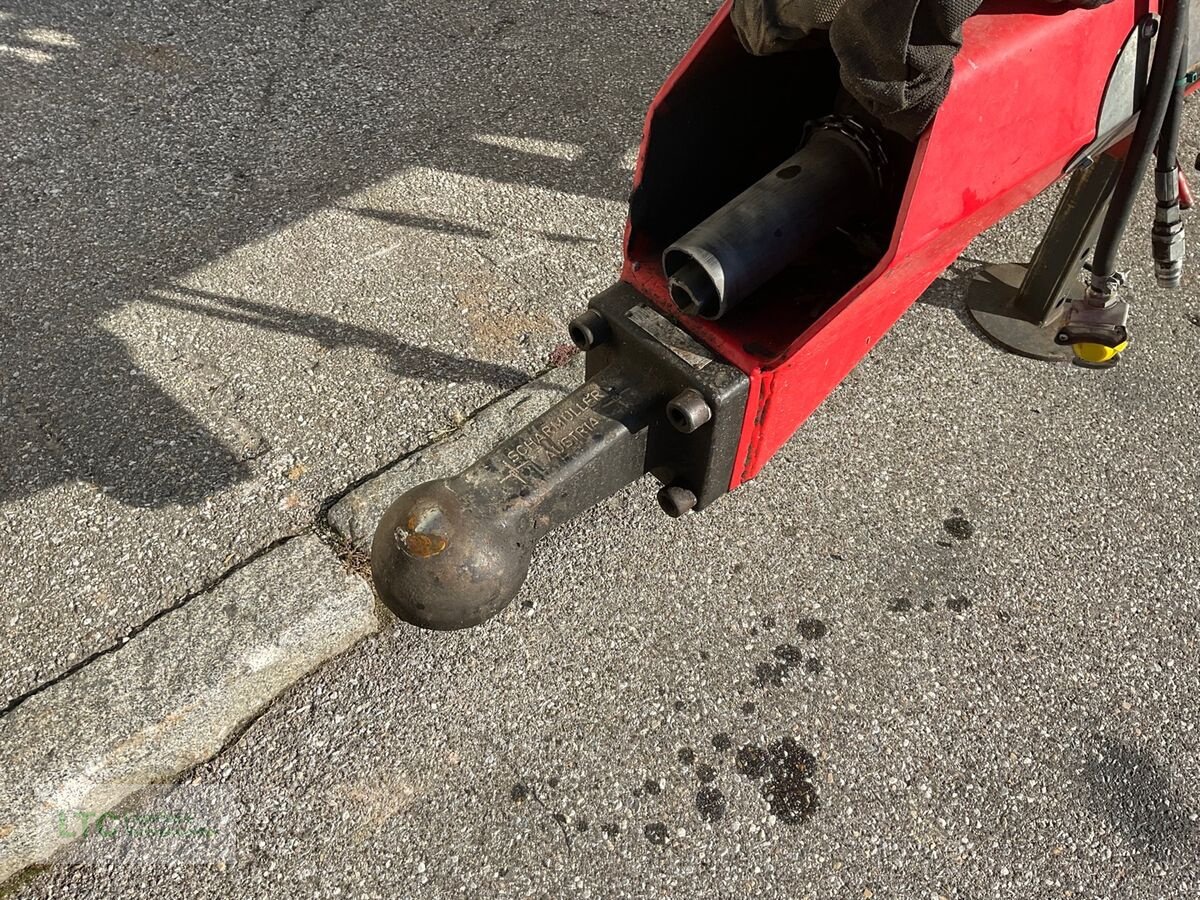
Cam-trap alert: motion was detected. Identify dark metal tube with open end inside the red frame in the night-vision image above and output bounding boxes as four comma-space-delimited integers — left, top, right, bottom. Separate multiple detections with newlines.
662, 125, 882, 319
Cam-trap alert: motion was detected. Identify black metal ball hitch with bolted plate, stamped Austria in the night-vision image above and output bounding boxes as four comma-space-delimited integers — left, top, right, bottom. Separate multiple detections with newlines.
371, 283, 749, 630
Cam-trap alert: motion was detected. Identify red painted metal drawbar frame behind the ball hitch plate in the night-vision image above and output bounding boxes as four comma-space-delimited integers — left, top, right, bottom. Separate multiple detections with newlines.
622, 0, 1157, 490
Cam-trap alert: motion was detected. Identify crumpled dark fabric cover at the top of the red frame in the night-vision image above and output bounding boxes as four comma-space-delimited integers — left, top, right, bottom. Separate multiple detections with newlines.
733, 0, 1110, 138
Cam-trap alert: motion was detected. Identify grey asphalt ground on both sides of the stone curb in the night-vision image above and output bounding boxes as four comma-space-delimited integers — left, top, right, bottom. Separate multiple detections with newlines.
0, 2, 1200, 898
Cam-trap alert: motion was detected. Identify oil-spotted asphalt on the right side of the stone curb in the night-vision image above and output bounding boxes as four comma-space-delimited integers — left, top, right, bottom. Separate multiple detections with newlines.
2, 6, 1200, 899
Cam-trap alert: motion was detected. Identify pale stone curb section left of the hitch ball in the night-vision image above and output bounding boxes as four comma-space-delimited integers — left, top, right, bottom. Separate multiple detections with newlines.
0, 535, 379, 882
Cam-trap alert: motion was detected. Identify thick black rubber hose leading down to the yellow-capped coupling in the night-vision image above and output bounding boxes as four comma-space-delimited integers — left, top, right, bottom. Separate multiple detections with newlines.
1092, 0, 1188, 285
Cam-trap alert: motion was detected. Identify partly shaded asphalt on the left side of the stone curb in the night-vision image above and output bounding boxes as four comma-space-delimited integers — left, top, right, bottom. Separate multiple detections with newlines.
0, 0, 708, 708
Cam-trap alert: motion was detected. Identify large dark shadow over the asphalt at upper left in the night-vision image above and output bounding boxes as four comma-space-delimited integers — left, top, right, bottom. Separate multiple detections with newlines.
0, 0, 686, 506
